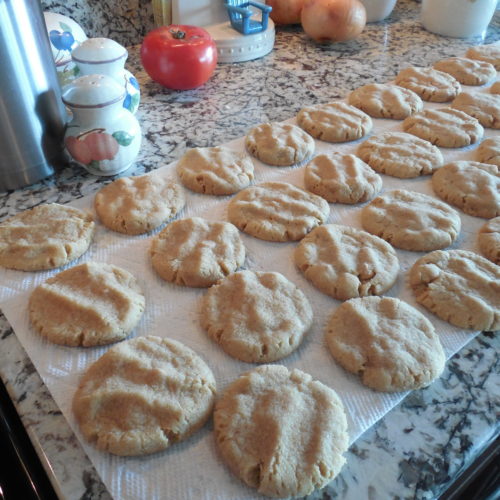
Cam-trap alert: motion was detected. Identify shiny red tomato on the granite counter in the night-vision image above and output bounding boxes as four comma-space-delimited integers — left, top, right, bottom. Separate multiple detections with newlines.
141, 24, 217, 90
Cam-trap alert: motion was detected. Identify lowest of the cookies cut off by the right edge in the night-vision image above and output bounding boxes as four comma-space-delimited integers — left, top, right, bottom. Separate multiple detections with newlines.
410, 250, 500, 331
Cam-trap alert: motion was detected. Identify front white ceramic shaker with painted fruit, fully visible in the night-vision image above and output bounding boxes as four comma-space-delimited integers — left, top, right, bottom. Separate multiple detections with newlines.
62, 75, 141, 175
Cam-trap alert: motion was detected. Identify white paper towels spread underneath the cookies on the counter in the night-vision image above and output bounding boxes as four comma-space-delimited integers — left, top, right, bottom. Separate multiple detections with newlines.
0, 77, 497, 500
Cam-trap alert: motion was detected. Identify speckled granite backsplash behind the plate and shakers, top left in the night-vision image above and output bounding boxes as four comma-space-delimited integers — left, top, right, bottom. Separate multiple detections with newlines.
41, 0, 154, 46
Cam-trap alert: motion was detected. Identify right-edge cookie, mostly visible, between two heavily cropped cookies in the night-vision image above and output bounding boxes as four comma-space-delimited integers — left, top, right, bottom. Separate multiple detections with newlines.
432, 161, 500, 218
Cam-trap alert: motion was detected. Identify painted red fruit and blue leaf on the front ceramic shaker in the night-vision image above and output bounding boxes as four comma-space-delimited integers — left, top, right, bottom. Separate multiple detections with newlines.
65, 128, 134, 170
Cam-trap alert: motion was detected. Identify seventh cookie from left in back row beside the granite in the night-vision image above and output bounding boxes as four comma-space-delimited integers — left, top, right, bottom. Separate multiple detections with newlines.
395, 67, 461, 102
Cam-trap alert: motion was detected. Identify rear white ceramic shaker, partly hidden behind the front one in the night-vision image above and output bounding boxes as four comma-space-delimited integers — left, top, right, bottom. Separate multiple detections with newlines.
71, 38, 140, 113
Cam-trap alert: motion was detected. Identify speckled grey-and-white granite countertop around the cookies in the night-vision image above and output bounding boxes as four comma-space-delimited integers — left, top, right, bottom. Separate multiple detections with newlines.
0, 0, 500, 499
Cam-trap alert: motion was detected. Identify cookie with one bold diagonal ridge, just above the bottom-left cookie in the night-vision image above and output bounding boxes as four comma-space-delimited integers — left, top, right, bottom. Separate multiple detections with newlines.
28, 262, 145, 346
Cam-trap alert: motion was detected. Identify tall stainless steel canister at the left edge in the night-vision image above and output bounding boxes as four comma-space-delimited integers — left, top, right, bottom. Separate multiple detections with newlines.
0, 0, 67, 191
